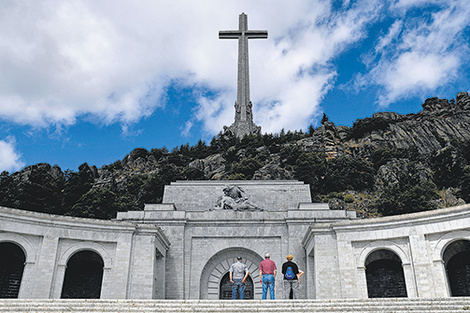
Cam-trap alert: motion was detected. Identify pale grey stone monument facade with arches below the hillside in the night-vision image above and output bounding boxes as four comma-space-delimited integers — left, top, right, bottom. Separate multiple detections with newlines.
0, 181, 470, 299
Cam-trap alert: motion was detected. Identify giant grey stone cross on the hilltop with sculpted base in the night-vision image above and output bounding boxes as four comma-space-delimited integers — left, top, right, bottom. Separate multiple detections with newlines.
219, 13, 268, 138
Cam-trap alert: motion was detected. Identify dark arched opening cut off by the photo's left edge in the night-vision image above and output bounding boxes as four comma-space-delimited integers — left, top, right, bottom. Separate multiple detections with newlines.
0, 242, 26, 298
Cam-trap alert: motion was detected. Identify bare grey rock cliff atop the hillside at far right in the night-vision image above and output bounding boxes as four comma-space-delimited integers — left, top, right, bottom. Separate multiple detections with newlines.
344, 92, 470, 155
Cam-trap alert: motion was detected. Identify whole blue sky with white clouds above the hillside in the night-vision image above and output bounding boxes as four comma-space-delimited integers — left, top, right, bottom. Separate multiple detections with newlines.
0, 0, 470, 172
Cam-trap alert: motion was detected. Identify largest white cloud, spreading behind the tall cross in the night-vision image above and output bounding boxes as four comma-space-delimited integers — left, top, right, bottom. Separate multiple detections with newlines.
0, 0, 379, 133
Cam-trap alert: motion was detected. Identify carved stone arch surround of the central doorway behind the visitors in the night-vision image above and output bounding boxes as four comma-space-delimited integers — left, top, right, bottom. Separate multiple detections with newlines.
200, 247, 263, 300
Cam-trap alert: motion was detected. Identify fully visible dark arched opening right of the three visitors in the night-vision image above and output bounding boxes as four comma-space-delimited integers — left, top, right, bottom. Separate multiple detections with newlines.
365, 249, 407, 298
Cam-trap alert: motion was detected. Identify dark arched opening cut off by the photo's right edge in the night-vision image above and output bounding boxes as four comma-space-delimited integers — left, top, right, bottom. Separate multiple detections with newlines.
443, 240, 470, 297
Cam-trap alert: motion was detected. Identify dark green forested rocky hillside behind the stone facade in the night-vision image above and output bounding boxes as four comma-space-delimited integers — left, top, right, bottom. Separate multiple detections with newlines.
0, 93, 470, 219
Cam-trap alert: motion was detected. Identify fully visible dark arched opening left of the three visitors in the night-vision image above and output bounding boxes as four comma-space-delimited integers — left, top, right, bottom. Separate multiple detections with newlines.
62, 251, 104, 299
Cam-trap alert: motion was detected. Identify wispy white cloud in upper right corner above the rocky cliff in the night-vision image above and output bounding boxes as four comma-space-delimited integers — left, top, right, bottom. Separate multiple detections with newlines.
355, 0, 470, 108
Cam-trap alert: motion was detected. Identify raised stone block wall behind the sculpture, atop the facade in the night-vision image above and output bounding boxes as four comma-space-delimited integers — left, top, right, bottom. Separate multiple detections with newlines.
163, 180, 312, 211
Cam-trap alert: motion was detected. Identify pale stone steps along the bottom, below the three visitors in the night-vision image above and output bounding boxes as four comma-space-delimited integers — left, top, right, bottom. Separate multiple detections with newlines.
0, 298, 470, 313
